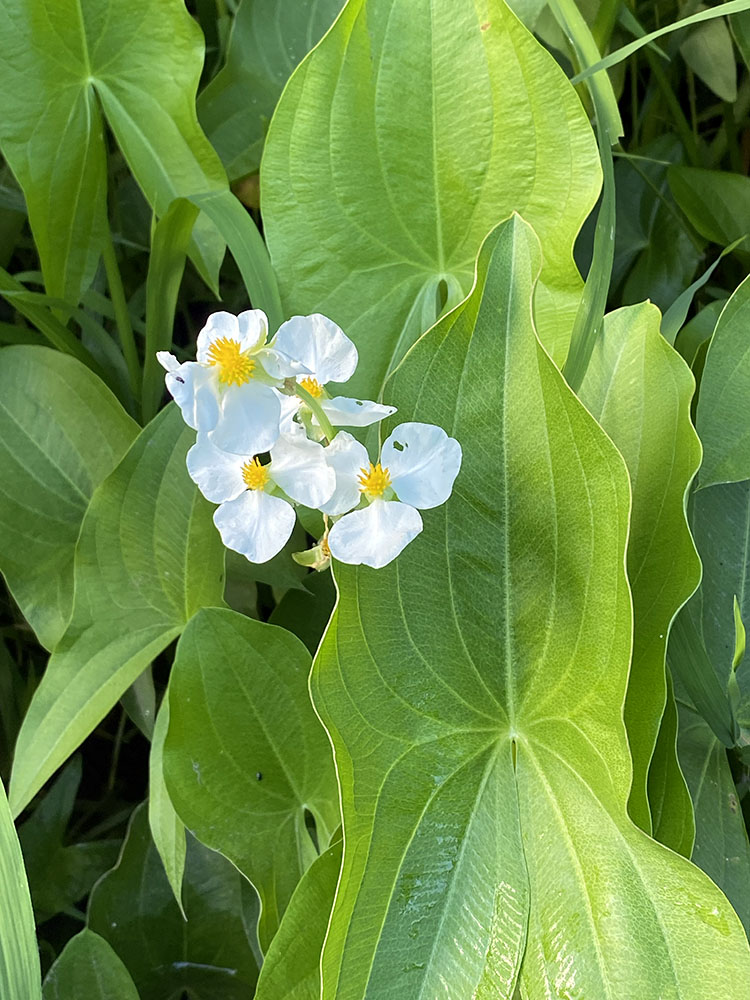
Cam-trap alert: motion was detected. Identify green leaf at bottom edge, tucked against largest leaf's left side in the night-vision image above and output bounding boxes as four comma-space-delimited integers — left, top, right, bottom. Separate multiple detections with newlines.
255, 838, 342, 1000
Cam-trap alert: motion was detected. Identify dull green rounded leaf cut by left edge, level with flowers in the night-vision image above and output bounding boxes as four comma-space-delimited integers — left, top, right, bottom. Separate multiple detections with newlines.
0, 345, 138, 649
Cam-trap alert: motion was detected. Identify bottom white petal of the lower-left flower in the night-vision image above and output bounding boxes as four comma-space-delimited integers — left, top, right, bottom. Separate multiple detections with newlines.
214, 490, 294, 562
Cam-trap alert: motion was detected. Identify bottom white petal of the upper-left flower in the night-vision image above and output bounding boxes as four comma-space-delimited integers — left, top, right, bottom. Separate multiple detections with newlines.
211, 381, 281, 456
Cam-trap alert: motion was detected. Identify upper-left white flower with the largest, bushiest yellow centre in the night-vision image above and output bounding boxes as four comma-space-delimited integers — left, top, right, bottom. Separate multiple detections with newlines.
157, 309, 306, 455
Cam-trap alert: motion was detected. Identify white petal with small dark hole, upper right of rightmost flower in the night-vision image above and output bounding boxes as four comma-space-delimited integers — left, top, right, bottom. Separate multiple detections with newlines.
380, 423, 461, 510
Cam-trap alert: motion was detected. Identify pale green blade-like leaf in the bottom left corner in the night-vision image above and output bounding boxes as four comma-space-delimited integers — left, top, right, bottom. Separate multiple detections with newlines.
0, 781, 42, 1000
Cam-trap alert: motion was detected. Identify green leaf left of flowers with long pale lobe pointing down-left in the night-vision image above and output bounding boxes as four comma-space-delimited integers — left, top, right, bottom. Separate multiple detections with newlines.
10, 405, 224, 813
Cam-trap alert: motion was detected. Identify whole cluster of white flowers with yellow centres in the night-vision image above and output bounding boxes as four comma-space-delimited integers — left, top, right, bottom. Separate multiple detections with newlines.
158, 309, 461, 569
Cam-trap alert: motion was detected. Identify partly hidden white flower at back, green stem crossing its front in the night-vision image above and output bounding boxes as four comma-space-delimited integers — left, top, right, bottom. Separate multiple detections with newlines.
275, 313, 396, 433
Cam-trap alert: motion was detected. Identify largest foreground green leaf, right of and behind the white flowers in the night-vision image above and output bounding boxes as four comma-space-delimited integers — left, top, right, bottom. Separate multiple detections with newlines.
313, 218, 750, 1000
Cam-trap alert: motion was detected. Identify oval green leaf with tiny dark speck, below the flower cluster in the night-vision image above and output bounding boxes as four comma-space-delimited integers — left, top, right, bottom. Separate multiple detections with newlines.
164, 608, 339, 949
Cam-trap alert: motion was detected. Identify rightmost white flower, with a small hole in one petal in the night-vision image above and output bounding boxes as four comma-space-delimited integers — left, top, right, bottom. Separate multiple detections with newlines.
320, 423, 461, 569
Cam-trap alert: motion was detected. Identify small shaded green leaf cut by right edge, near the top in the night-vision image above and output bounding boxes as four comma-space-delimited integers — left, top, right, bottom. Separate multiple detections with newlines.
667, 166, 750, 259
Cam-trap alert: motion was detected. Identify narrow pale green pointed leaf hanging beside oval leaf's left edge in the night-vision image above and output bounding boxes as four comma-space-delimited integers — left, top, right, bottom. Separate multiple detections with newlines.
148, 694, 187, 919
